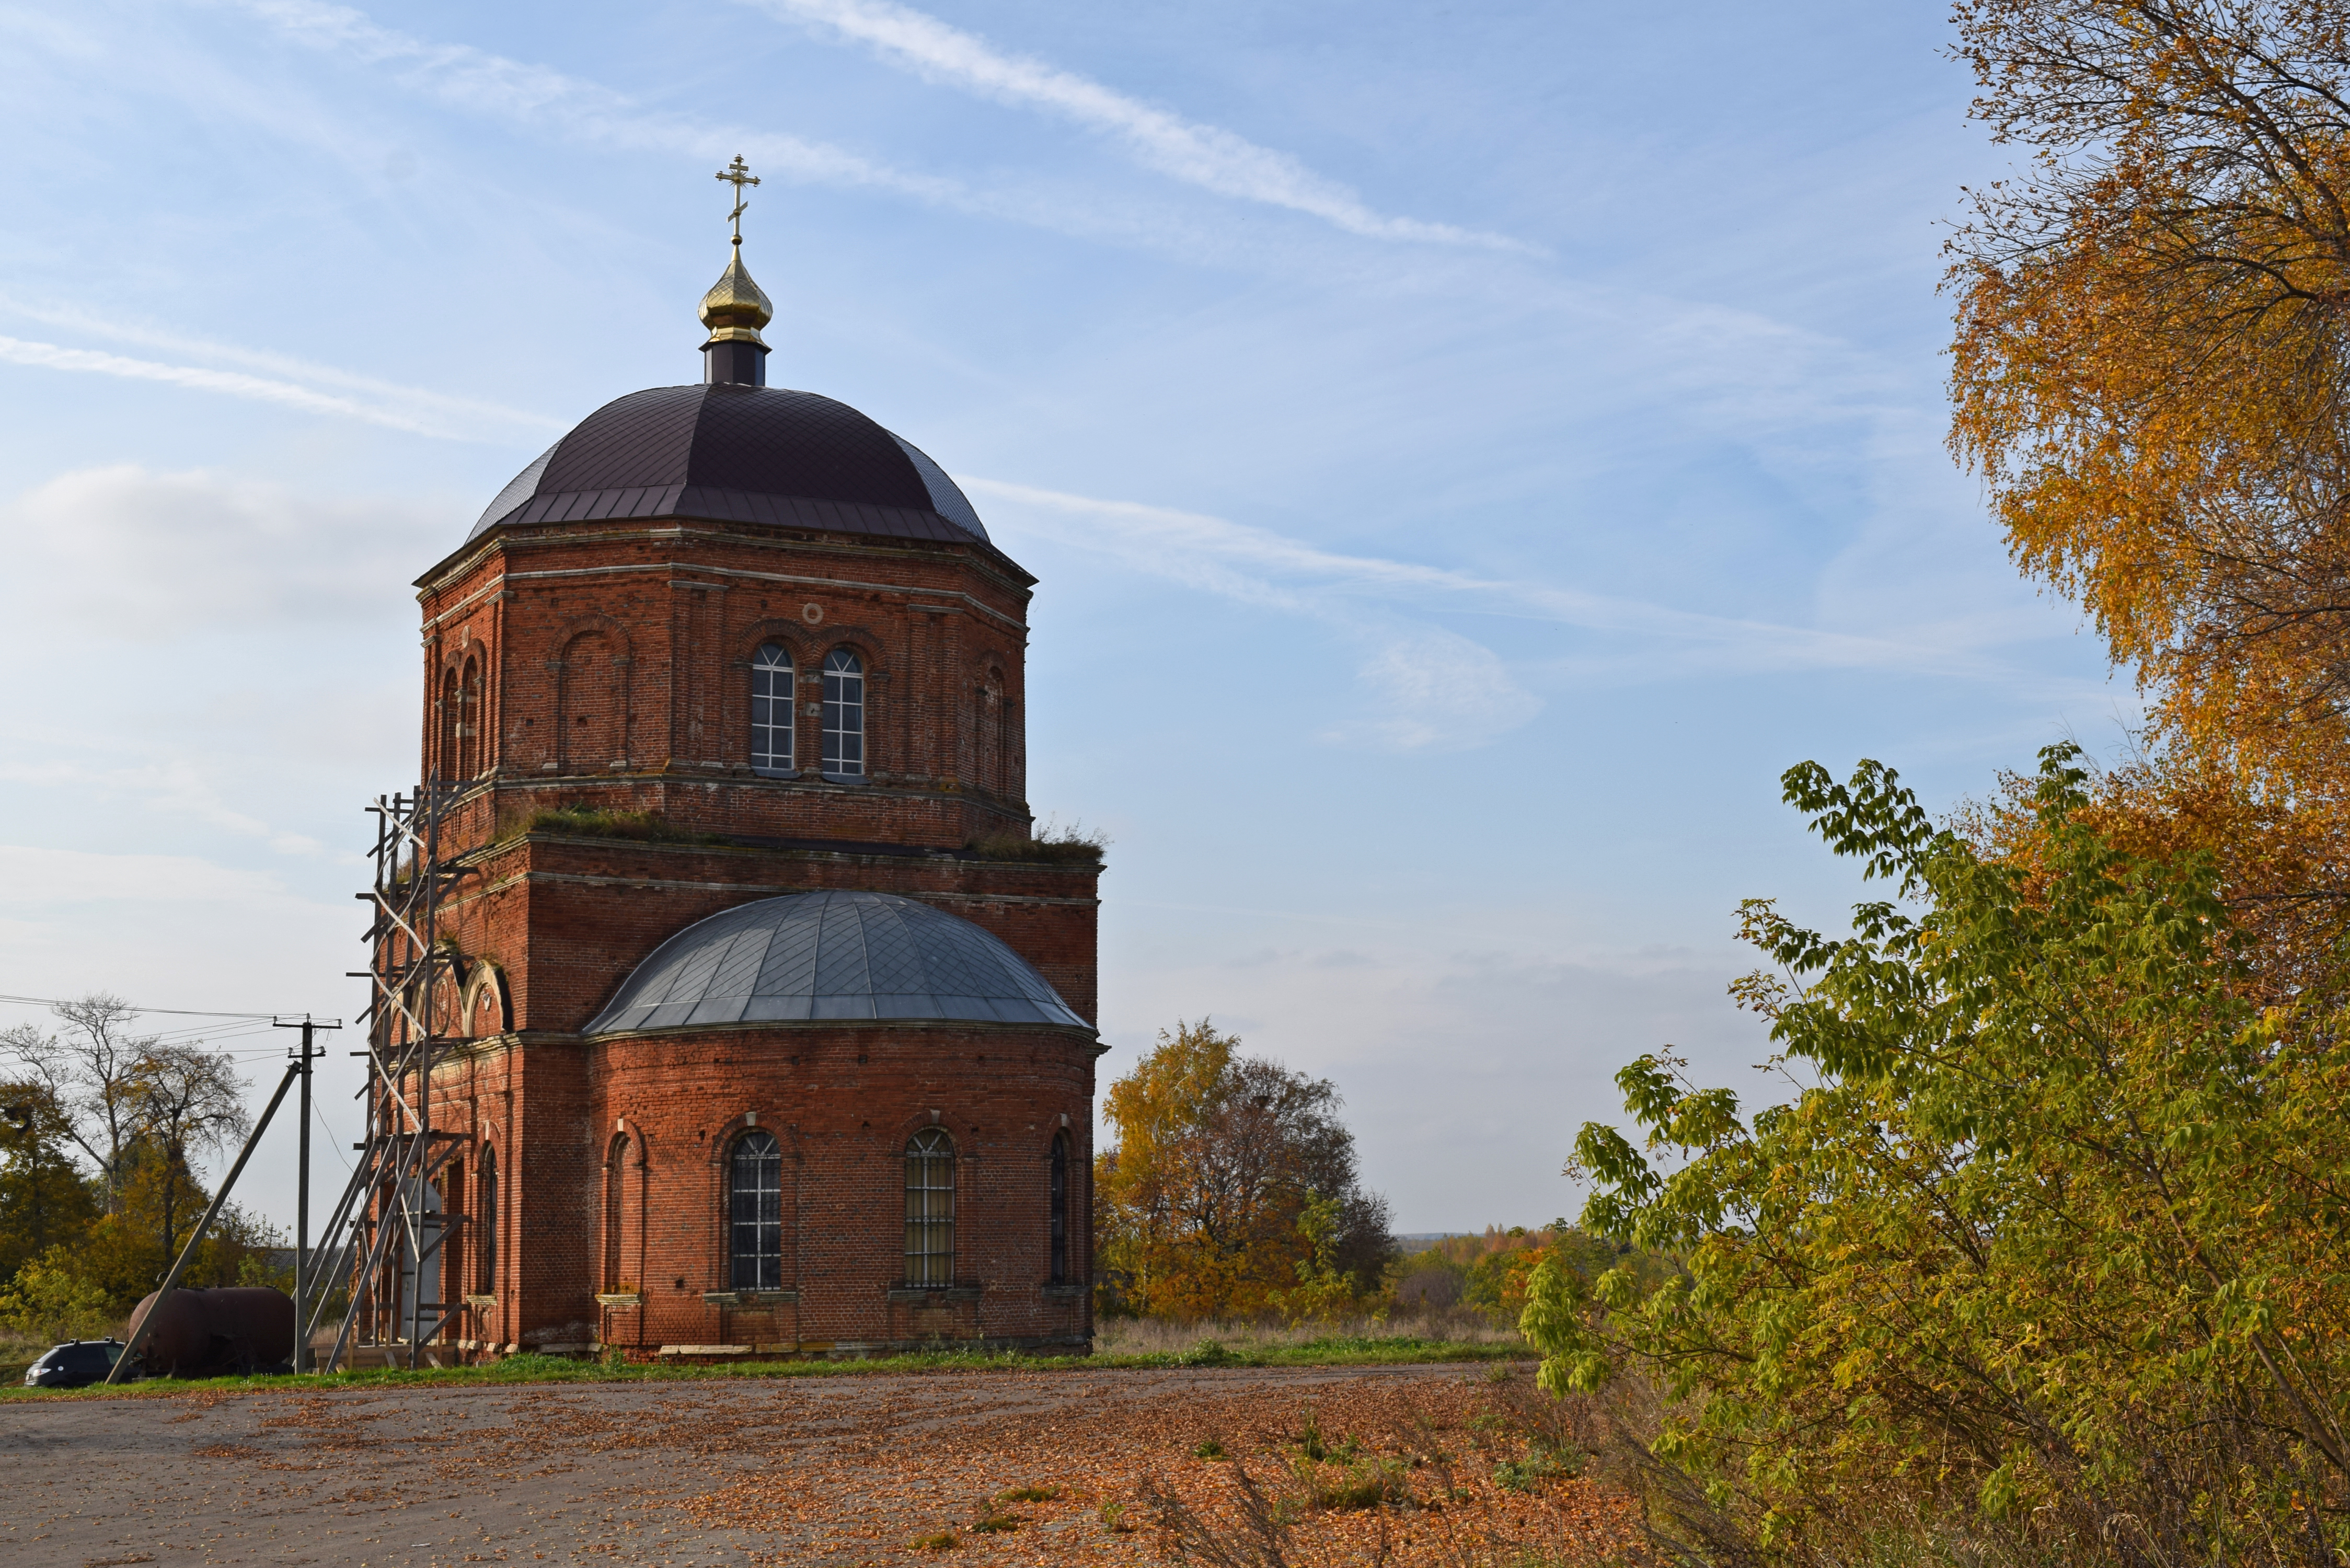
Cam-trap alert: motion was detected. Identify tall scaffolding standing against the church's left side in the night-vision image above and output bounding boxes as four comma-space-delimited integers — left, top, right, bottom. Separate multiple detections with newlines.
301, 783, 468, 1373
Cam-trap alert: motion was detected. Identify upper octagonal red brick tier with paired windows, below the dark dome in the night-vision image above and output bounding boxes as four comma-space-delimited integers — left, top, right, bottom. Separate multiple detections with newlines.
418, 522, 1029, 849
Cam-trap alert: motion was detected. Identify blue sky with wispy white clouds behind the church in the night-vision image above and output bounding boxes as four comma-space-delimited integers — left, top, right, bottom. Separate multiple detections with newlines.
0, 0, 2136, 1229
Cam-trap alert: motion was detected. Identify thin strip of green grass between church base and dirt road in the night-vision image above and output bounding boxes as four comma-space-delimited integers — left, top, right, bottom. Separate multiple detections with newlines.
0, 1335, 1535, 1403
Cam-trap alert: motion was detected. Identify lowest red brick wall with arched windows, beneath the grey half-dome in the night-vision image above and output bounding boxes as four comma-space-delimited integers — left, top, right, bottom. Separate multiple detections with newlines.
435, 1023, 1098, 1352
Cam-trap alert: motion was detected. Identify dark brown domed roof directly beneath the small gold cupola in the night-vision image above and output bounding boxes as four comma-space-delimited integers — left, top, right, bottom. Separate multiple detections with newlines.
465, 383, 987, 543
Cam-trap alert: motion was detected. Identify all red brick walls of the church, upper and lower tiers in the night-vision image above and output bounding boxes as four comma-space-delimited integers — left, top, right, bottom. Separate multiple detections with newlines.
395, 510, 1100, 1352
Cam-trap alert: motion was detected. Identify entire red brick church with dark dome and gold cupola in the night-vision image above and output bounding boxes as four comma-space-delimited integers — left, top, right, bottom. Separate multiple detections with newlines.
407, 208, 1102, 1354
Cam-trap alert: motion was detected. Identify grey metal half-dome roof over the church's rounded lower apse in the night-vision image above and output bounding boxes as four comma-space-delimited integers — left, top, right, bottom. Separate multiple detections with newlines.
585, 891, 1093, 1034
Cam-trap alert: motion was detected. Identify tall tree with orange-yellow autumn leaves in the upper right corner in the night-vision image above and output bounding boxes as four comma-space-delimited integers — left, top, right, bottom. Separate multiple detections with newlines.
1948, 0, 2350, 799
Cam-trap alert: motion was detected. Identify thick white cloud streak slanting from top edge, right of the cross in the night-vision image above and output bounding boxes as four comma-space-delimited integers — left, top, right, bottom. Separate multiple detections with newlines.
745, 0, 1539, 251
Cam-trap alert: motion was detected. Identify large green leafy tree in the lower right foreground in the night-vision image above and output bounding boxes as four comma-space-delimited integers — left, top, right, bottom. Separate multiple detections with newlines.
1520, 747, 2350, 1566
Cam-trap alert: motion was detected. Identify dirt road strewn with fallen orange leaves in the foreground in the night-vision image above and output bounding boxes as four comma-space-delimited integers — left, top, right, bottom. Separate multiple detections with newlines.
0, 1366, 1619, 1568
